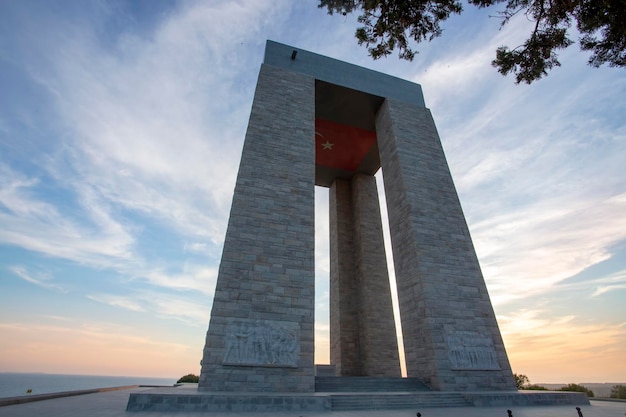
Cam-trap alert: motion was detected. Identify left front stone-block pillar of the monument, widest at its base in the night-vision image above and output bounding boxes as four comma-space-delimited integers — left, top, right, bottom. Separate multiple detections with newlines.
199, 65, 315, 392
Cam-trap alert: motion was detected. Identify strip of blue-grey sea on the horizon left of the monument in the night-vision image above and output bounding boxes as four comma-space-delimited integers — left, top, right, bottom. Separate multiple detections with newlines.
0, 372, 178, 398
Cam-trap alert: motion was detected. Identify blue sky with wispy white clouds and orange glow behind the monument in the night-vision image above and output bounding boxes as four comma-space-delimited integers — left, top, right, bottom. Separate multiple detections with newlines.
0, 0, 626, 383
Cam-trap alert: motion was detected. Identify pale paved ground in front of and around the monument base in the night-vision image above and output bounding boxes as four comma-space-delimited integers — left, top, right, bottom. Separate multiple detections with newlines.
0, 388, 626, 417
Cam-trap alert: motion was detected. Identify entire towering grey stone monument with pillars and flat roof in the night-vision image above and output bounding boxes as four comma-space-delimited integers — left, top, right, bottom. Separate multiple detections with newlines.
199, 41, 515, 393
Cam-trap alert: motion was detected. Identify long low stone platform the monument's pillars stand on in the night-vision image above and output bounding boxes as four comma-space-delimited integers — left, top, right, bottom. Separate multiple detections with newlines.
126, 377, 589, 412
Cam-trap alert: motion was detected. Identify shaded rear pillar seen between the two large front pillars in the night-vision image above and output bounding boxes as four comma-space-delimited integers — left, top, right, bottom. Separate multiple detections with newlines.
329, 174, 401, 377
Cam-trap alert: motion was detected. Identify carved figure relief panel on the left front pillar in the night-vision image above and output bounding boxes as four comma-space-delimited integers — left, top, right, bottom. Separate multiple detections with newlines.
223, 319, 300, 367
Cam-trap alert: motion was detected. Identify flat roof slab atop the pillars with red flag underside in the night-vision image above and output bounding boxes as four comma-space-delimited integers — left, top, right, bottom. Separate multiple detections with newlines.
264, 40, 424, 187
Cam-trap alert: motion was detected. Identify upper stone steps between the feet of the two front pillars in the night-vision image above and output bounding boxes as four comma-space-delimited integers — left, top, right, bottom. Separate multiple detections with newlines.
315, 376, 430, 392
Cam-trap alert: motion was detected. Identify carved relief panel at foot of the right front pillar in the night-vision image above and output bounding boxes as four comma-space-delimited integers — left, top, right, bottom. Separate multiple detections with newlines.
446, 331, 500, 370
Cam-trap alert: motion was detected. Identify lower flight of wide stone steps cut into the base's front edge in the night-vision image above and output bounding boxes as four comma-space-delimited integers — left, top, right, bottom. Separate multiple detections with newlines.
331, 392, 472, 411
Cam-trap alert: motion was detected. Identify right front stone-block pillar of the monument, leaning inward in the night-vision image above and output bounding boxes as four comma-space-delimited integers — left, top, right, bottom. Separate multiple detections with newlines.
376, 99, 514, 390
